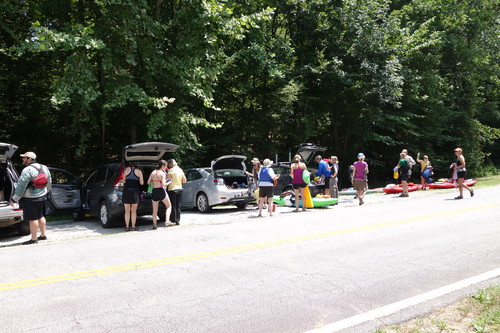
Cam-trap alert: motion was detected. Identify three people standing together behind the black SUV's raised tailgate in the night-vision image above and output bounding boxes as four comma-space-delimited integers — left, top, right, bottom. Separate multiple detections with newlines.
122, 159, 187, 231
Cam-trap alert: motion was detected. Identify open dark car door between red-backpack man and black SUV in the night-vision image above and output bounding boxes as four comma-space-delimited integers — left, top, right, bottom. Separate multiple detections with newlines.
49, 168, 81, 210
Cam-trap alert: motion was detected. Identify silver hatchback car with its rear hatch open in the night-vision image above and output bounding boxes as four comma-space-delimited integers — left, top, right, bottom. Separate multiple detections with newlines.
182, 155, 254, 213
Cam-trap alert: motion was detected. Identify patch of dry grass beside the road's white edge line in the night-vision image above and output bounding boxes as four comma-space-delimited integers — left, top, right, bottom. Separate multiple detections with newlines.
375, 285, 500, 333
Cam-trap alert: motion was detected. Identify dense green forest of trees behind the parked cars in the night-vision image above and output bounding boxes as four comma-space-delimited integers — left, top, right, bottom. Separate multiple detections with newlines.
0, 0, 500, 184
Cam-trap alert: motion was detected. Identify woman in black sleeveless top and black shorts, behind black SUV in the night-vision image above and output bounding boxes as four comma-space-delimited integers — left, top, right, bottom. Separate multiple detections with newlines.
122, 162, 144, 231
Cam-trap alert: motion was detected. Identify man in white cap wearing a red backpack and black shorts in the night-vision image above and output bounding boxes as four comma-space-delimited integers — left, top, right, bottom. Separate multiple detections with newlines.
10, 151, 52, 244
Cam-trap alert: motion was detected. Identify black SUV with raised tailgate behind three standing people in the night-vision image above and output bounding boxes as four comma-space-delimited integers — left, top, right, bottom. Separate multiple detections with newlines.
73, 142, 179, 228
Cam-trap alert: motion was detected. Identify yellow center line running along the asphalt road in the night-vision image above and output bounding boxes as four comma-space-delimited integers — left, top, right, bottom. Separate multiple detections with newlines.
0, 203, 500, 291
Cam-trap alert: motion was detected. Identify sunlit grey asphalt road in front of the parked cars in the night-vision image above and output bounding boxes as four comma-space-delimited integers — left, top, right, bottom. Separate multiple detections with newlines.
0, 186, 500, 333
